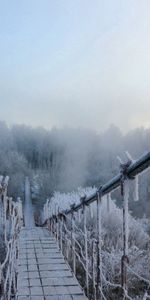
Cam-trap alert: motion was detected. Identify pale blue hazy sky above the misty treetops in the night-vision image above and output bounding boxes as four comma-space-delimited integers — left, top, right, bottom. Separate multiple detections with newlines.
0, 0, 150, 131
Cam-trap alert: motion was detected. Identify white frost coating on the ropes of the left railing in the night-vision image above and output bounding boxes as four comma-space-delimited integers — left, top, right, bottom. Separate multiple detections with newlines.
0, 177, 21, 300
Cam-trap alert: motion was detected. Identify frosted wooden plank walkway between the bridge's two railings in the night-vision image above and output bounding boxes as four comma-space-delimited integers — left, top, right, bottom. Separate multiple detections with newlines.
16, 227, 87, 300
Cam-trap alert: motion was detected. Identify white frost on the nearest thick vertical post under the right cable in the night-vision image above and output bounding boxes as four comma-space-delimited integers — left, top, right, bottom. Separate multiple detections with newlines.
123, 179, 129, 255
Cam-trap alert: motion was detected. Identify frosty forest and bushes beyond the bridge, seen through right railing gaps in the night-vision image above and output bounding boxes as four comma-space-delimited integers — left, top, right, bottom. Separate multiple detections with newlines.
0, 122, 150, 300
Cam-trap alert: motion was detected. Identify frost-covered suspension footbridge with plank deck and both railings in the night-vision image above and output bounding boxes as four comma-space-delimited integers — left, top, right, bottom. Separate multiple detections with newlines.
0, 152, 150, 300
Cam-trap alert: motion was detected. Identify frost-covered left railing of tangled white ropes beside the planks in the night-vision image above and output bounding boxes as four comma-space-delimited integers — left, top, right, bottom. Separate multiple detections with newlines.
0, 176, 22, 300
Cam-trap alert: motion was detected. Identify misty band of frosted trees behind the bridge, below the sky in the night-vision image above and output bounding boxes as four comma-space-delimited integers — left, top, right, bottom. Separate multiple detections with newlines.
0, 122, 150, 216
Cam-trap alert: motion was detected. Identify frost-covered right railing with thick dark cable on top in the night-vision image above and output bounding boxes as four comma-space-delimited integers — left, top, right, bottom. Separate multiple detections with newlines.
44, 152, 150, 300
